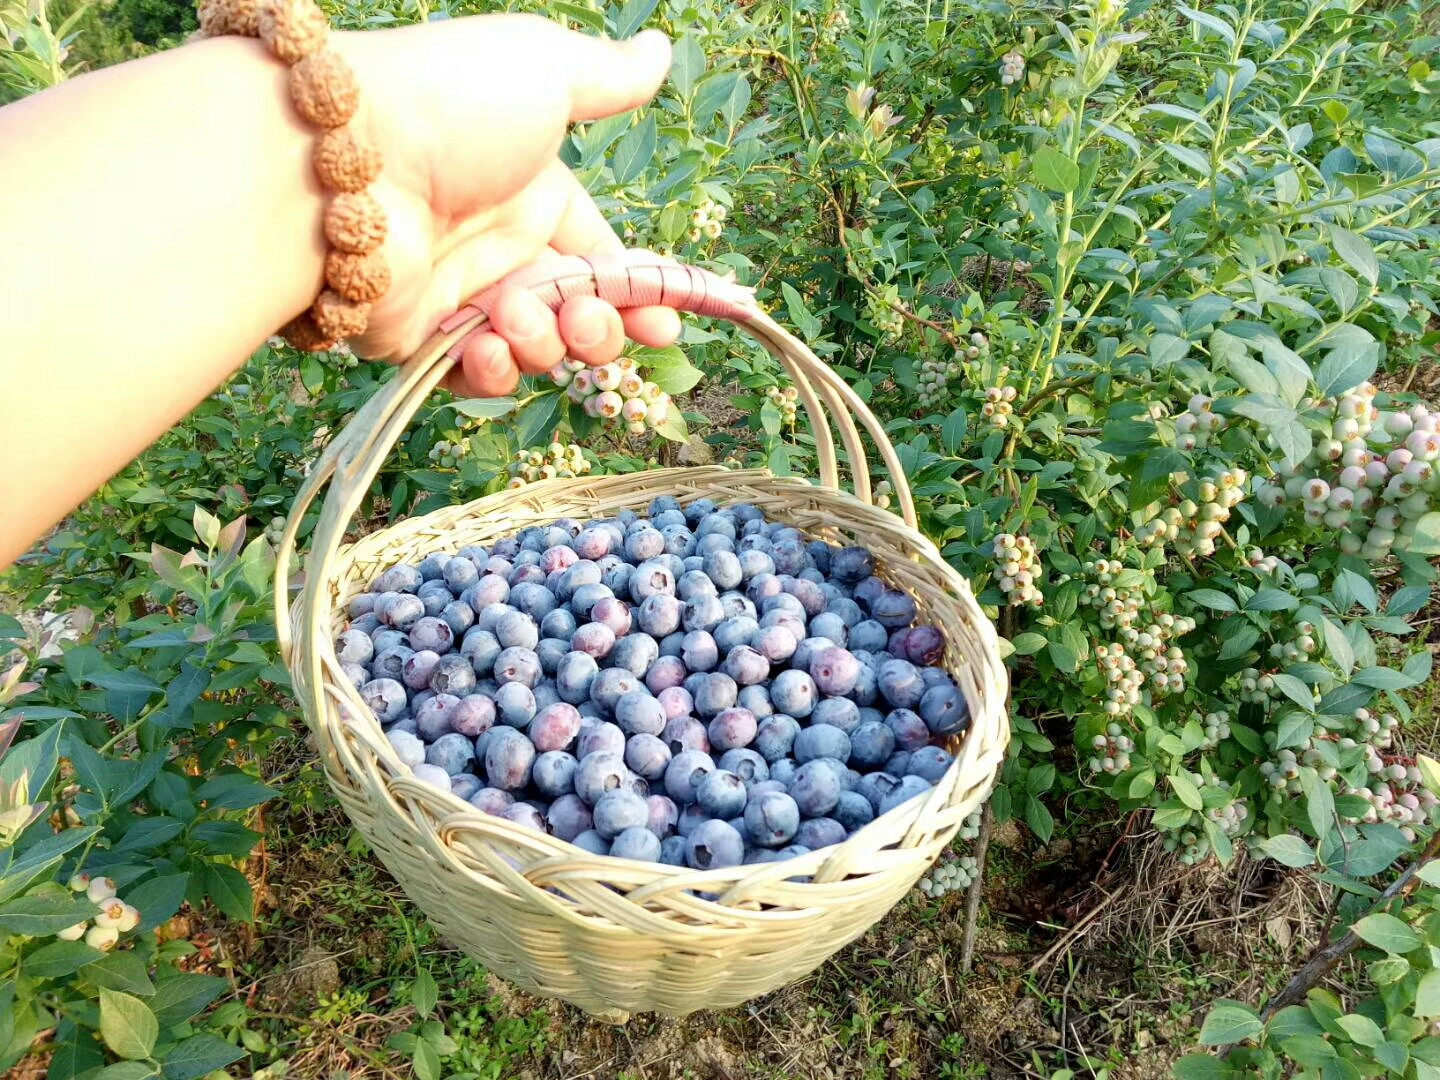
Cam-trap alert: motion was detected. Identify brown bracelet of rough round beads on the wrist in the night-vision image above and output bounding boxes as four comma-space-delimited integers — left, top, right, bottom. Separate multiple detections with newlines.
197, 0, 390, 351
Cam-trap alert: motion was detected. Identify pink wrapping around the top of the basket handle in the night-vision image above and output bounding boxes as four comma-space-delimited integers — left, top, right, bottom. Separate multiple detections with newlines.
439, 251, 756, 360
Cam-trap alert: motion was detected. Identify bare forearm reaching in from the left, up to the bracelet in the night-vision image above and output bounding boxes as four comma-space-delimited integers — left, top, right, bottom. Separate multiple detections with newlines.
0, 39, 324, 567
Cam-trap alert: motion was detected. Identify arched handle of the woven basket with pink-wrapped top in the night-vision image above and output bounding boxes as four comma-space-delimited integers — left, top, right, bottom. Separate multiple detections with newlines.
275, 251, 916, 665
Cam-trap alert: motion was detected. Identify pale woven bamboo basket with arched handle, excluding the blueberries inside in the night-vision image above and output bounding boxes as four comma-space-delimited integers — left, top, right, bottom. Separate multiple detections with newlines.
275, 255, 1009, 1022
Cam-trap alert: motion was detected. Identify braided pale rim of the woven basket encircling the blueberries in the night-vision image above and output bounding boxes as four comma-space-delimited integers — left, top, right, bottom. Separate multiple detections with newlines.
294, 465, 1011, 898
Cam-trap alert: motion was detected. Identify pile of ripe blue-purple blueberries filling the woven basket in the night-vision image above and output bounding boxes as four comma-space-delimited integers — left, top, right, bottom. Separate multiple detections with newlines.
336, 495, 971, 870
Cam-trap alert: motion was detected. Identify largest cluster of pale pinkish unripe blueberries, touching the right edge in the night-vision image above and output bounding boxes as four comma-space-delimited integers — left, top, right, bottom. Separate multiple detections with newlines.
1256, 383, 1440, 562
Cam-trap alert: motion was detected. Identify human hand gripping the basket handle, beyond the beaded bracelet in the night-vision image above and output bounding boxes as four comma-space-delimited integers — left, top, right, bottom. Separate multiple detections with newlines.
333, 14, 680, 396
